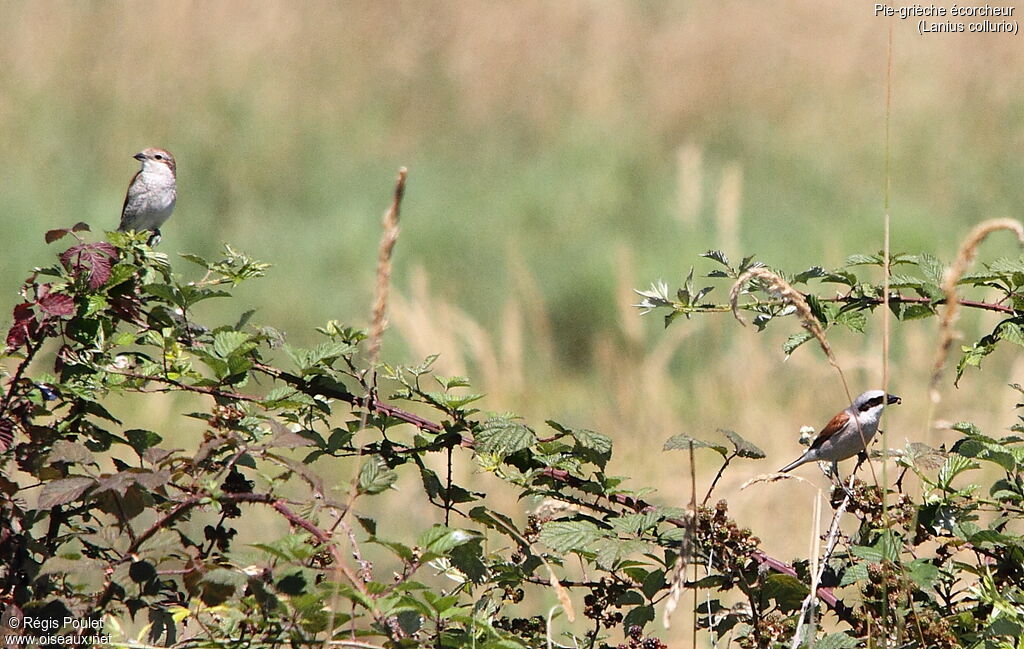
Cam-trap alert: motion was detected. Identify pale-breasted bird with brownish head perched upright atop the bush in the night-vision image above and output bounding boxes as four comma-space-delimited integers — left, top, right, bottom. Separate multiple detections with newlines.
118, 148, 177, 246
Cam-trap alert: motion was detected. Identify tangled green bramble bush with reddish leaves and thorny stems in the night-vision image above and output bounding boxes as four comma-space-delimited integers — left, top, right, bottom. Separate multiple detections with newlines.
0, 213, 1024, 649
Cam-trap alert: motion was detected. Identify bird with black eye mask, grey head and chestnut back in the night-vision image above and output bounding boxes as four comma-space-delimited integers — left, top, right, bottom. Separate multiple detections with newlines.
779, 390, 902, 476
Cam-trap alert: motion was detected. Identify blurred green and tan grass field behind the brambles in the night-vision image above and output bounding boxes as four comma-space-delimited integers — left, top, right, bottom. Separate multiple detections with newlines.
0, 0, 1024, 638
